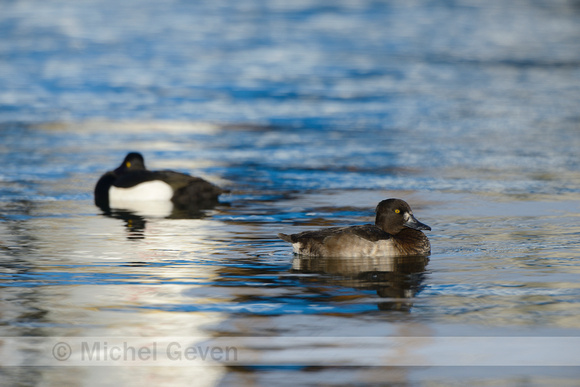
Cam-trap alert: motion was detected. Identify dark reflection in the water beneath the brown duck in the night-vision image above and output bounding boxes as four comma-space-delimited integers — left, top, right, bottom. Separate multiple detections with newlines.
292, 255, 429, 311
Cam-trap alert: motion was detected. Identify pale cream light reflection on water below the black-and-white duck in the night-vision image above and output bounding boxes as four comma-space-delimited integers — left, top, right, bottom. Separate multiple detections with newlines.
0, 202, 245, 385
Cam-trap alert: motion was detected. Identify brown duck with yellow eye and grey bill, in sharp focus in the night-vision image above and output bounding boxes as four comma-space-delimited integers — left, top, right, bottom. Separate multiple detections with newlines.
278, 198, 431, 258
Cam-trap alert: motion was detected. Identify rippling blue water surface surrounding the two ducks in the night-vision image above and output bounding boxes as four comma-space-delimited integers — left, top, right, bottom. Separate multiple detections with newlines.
0, 0, 580, 386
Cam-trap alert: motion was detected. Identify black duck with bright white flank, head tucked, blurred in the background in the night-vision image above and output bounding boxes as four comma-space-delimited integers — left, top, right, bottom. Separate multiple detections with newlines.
94, 152, 226, 210
